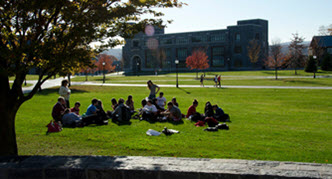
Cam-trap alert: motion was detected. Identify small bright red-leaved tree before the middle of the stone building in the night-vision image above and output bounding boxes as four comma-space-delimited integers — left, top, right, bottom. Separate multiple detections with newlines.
186, 49, 209, 78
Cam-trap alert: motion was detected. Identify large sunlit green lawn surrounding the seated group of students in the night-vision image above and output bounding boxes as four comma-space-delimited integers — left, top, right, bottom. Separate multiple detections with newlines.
16, 86, 332, 163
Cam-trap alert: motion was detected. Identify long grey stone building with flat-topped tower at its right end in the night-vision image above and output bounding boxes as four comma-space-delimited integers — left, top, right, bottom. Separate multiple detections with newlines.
122, 19, 269, 73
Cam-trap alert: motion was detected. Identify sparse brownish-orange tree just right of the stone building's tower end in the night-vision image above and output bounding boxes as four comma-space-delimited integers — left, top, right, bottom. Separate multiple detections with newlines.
265, 41, 285, 80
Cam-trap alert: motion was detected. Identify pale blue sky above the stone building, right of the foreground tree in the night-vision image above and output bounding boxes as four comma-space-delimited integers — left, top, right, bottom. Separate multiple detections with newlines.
158, 0, 332, 42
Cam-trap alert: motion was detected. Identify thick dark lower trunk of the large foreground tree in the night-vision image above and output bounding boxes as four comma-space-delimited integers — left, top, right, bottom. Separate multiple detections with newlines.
0, 101, 18, 156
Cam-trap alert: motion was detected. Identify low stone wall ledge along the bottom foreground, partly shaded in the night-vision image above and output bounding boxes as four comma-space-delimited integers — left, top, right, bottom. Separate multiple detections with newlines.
0, 156, 332, 179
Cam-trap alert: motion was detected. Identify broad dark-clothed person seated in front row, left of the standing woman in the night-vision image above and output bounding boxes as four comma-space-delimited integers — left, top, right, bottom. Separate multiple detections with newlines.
112, 98, 131, 122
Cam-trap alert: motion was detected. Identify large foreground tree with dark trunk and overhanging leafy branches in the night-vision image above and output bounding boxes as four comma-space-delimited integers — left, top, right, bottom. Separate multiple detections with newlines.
0, 0, 184, 155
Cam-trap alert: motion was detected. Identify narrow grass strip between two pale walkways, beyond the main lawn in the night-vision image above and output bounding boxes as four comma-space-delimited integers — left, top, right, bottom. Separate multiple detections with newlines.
72, 72, 332, 86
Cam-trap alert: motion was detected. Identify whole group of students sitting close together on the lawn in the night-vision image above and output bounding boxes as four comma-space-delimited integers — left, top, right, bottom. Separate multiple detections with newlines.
52, 92, 229, 127
